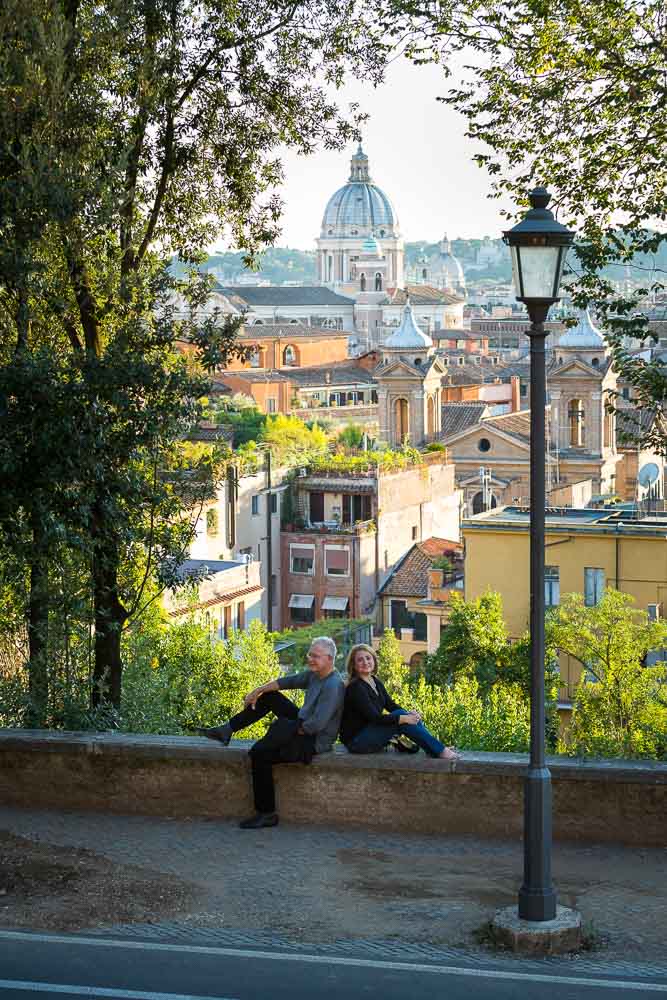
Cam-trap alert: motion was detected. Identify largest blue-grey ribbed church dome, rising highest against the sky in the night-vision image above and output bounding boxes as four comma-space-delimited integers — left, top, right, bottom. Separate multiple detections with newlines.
322, 145, 398, 237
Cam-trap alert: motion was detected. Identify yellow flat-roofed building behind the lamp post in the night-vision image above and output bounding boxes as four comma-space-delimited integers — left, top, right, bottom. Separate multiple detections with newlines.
462, 507, 667, 701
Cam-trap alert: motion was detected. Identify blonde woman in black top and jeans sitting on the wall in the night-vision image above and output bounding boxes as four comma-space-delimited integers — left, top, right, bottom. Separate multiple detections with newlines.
340, 643, 459, 760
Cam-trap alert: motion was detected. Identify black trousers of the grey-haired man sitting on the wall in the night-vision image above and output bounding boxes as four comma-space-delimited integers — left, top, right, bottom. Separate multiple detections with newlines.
229, 691, 315, 813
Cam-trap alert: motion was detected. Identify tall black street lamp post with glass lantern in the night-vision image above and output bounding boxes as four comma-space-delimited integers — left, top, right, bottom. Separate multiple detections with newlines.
503, 188, 574, 920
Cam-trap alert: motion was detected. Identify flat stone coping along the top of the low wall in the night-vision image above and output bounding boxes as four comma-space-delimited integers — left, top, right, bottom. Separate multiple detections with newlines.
0, 729, 667, 785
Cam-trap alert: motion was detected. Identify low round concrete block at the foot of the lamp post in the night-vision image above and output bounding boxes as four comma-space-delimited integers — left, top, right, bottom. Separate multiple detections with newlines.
491, 906, 581, 955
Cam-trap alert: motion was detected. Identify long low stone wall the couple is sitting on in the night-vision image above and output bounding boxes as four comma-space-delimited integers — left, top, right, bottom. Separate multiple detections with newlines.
0, 730, 667, 847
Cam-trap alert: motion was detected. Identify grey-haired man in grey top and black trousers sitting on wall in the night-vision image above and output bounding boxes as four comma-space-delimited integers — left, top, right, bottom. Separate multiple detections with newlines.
197, 636, 345, 830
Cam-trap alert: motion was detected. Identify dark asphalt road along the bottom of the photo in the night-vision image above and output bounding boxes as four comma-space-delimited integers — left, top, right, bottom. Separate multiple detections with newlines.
0, 931, 667, 1000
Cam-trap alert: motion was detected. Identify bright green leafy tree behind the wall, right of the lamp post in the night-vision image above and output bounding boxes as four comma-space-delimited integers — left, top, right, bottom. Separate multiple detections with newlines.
552, 589, 667, 757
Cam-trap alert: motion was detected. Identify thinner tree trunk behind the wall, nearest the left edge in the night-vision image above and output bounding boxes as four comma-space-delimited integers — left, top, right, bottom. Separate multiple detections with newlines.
26, 513, 49, 729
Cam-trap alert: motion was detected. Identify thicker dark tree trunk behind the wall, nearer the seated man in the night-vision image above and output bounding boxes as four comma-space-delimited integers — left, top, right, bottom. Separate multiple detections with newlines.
91, 512, 127, 709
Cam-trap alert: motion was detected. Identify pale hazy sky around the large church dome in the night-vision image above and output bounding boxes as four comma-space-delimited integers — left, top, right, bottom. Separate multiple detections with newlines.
236, 59, 507, 249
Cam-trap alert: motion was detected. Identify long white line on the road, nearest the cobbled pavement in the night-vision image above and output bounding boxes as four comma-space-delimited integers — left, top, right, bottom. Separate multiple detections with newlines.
0, 931, 667, 1000
